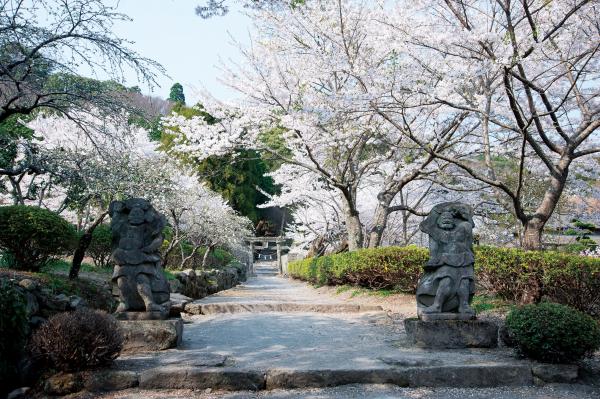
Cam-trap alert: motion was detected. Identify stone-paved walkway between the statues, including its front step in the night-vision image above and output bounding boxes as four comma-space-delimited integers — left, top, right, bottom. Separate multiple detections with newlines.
106, 268, 600, 398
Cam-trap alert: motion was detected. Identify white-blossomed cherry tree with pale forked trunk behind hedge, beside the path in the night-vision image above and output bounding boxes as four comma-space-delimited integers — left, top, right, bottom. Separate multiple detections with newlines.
166, 2, 463, 250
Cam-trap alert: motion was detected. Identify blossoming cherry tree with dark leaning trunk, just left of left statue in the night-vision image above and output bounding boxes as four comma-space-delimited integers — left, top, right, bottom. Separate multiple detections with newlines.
18, 110, 175, 278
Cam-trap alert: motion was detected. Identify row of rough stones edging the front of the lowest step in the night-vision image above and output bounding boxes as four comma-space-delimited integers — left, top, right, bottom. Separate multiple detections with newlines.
45, 362, 579, 395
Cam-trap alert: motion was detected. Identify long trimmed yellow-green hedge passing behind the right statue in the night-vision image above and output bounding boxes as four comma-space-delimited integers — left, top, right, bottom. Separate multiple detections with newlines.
288, 246, 600, 317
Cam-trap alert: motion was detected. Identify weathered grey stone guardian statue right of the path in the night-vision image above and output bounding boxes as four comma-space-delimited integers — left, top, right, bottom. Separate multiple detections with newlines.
417, 202, 475, 320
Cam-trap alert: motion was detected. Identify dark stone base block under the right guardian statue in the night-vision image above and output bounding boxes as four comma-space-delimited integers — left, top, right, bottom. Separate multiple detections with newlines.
404, 319, 498, 349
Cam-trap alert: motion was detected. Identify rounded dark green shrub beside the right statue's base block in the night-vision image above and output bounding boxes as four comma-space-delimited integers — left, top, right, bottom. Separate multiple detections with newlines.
506, 302, 600, 363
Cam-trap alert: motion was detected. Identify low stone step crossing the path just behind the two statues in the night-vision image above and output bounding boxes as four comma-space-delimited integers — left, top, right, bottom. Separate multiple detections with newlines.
184, 302, 383, 315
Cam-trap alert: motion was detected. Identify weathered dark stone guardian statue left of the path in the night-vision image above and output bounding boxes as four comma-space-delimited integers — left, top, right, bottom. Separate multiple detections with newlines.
109, 198, 170, 313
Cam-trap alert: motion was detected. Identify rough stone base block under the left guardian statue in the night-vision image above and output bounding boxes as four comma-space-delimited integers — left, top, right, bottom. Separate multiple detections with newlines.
119, 319, 183, 353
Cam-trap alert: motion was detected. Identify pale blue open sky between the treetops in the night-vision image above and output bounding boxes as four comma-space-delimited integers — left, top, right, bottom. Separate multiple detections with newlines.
105, 0, 251, 105
